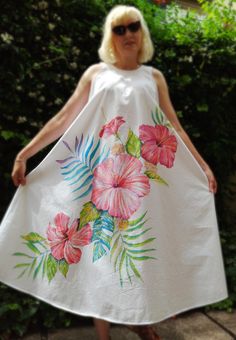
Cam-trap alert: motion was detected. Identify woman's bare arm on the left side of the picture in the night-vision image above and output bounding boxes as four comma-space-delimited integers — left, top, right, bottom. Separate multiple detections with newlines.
12, 64, 101, 186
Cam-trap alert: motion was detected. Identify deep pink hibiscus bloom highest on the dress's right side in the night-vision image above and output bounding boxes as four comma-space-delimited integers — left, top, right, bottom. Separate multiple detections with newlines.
139, 125, 177, 168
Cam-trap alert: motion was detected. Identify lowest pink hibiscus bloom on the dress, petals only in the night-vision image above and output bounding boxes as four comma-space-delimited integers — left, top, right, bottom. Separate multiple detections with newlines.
47, 213, 92, 264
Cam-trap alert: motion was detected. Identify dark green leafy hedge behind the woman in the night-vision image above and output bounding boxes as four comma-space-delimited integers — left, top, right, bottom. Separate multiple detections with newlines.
0, 0, 236, 335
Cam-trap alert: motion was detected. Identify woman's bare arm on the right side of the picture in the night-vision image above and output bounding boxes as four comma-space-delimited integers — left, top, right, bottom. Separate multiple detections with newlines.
153, 69, 217, 193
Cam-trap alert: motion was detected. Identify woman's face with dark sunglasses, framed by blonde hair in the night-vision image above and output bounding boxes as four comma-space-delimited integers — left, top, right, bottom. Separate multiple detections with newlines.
112, 18, 142, 61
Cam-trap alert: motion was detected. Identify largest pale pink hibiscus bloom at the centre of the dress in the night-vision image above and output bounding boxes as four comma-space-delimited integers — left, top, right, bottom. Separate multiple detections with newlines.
91, 154, 150, 220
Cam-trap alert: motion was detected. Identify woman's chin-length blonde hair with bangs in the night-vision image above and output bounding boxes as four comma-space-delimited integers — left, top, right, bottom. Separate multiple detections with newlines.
98, 5, 154, 64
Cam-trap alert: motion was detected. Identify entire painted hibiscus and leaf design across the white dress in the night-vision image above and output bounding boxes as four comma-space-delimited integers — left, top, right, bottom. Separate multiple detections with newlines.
14, 108, 177, 286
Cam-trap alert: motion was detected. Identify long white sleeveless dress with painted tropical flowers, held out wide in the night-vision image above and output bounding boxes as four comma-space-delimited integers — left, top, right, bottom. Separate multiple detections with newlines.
0, 63, 228, 324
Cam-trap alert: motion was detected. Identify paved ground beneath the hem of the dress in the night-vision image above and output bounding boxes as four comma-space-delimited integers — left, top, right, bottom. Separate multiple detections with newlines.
20, 311, 236, 340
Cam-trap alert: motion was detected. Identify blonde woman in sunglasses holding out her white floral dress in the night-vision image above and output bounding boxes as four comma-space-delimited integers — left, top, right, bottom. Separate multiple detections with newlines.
0, 6, 227, 340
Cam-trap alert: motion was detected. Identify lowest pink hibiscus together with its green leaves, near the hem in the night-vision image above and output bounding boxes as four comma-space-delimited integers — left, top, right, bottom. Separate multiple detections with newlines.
13, 212, 93, 282
